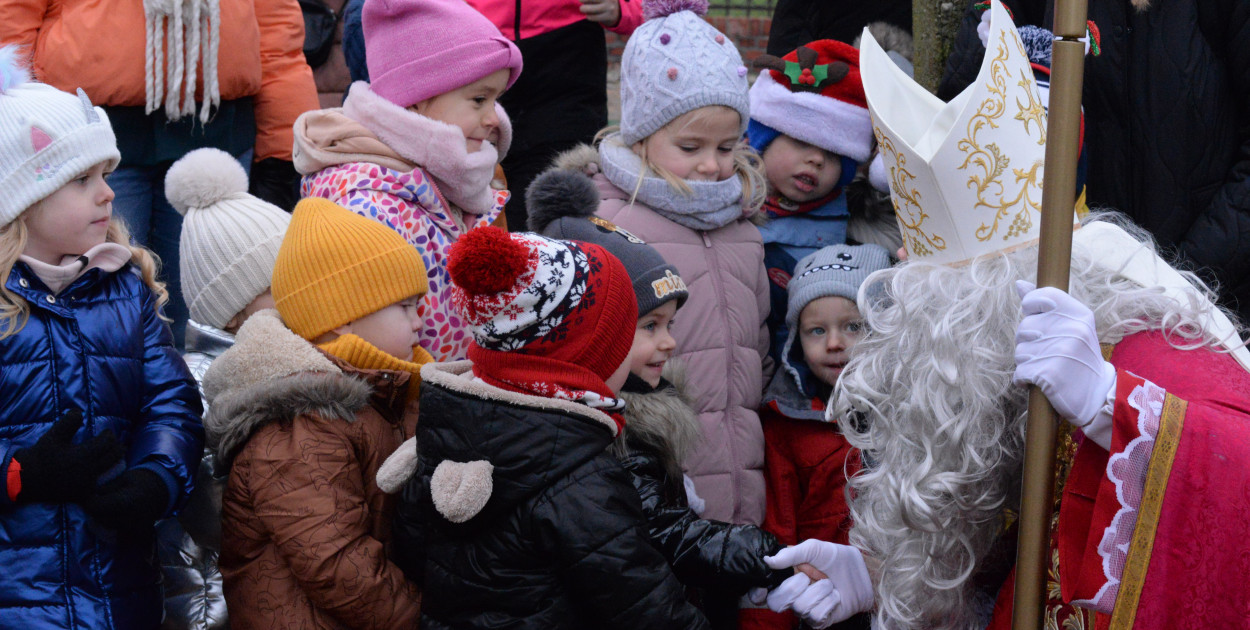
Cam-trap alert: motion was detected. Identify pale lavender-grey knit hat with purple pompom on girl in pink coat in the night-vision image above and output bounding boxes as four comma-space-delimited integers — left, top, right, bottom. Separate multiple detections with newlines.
620, 0, 750, 146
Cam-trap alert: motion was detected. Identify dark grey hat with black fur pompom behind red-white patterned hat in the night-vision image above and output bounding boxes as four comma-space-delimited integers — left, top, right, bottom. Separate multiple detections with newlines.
525, 170, 690, 318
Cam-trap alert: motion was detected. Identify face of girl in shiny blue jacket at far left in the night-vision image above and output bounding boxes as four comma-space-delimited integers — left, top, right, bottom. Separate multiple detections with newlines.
21, 163, 114, 265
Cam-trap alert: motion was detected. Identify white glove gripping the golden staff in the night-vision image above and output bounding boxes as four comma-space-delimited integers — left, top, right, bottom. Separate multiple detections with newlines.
1013, 280, 1115, 448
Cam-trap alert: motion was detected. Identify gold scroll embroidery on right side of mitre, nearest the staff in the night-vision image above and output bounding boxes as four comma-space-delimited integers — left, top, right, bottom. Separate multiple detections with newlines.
956, 30, 1046, 241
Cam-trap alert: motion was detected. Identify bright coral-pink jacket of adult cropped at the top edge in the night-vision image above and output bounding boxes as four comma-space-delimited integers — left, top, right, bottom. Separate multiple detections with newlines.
468, 0, 643, 41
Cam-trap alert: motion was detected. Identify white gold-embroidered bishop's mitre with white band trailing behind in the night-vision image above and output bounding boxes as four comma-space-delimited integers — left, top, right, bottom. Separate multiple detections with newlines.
860, 0, 1250, 370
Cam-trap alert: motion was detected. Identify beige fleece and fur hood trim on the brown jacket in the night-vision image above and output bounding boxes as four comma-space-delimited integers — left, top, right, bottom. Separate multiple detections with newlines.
204, 309, 373, 466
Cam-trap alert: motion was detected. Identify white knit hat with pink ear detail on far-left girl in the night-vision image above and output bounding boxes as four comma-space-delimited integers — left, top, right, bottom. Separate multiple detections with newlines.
0, 46, 121, 226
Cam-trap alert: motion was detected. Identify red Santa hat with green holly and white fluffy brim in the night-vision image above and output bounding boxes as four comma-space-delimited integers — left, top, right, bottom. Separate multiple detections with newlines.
746, 40, 873, 164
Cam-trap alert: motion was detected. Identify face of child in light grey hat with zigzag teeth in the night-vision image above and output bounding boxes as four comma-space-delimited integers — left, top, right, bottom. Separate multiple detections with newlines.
799, 295, 864, 386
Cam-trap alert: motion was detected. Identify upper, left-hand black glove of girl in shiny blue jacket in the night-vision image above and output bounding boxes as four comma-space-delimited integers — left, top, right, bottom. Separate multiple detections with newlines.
10, 409, 125, 503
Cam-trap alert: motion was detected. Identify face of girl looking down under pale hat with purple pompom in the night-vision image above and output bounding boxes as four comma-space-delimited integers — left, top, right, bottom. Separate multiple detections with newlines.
635, 105, 741, 181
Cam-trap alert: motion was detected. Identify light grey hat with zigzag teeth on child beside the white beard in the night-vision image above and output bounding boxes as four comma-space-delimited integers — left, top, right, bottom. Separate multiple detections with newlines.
781, 244, 890, 390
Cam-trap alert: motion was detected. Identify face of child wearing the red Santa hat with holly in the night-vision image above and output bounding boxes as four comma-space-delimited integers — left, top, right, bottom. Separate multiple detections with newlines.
763, 134, 843, 204
